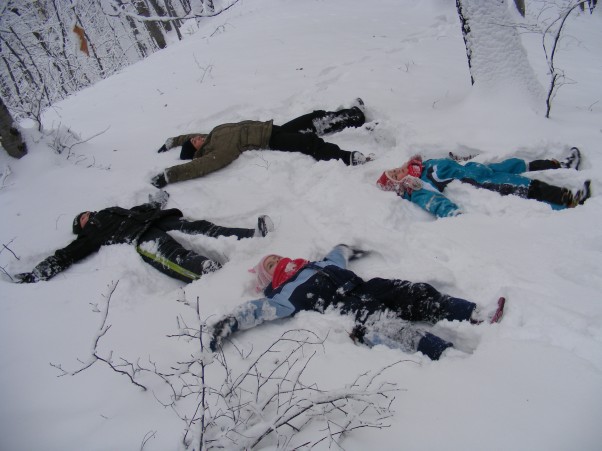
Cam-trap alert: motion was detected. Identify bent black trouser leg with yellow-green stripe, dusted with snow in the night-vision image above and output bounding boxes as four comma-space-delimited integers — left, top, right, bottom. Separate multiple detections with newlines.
136, 227, 221, 282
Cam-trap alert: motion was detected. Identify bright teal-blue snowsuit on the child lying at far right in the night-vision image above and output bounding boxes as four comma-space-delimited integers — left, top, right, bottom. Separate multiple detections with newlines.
403, 158, 566, 218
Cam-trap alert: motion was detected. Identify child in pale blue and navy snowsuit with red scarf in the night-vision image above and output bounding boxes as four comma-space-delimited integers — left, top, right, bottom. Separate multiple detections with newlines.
209, 244, 505, 360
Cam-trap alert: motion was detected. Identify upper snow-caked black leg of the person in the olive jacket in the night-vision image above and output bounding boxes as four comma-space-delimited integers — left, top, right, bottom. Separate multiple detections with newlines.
280, 107, 366, 136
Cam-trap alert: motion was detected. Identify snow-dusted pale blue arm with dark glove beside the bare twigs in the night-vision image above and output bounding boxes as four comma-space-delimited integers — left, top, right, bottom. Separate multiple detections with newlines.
209, 296, 296, 352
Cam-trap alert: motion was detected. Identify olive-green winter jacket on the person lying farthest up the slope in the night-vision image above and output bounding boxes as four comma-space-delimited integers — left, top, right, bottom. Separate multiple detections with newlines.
165, 121, 272, 183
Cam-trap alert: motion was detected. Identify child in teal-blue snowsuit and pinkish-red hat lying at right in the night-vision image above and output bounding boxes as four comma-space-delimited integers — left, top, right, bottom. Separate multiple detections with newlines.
376, 147, 591, 217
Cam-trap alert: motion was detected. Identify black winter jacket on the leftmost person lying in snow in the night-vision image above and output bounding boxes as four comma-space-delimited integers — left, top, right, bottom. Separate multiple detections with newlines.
33, 203, 182, 280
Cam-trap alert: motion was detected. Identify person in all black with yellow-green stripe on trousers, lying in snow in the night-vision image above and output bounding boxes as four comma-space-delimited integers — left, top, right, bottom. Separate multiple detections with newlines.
15, 191, 274, 283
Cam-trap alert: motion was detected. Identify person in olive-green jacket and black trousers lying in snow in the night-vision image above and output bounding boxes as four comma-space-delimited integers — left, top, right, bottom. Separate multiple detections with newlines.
151, 99, 374, 188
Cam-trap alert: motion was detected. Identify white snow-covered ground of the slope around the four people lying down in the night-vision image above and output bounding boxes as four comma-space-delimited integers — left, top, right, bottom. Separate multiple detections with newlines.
0, 0, 602, 451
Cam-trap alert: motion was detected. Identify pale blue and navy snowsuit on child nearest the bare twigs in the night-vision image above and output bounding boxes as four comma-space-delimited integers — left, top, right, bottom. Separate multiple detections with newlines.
213, 245, 476, 360
